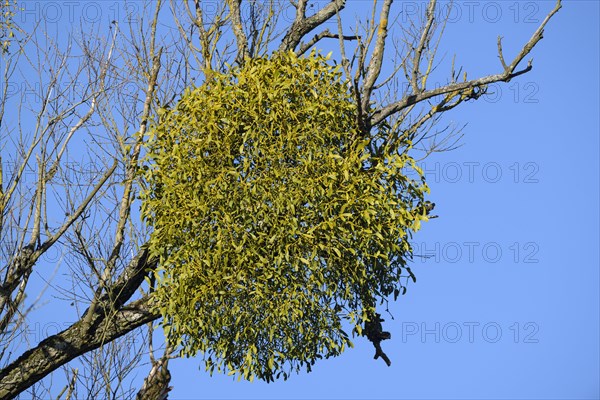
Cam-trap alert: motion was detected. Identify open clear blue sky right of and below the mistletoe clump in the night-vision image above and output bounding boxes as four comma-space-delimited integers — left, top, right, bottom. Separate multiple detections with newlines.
2, 0, 600, 399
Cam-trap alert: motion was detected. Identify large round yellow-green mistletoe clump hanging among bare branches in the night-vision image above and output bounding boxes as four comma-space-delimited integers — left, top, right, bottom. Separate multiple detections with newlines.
142, 52, 428, 381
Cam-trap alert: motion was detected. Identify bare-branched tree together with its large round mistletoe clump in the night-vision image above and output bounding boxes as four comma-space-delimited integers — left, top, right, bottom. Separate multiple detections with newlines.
0, 0, 561, 399
